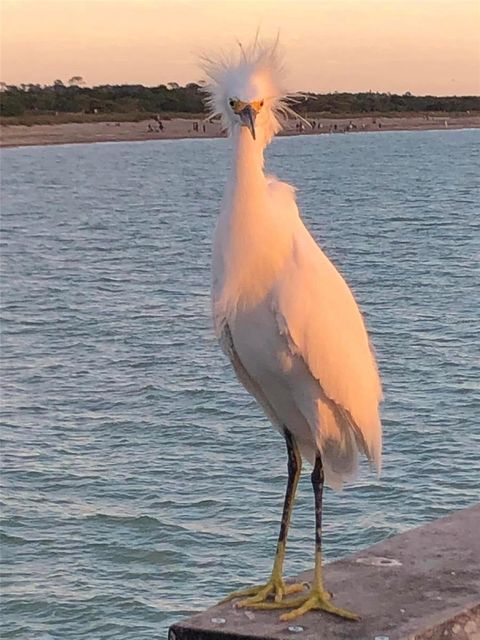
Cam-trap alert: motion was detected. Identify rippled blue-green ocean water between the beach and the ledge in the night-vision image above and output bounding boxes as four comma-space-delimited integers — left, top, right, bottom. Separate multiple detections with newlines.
1, 130, 480, 640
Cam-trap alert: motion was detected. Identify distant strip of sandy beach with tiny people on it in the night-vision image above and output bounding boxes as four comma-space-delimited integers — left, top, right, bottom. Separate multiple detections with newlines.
0, 115, 480, 147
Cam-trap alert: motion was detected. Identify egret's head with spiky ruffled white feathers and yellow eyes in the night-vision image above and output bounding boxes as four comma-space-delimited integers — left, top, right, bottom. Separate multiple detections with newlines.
203, 41, 290, 144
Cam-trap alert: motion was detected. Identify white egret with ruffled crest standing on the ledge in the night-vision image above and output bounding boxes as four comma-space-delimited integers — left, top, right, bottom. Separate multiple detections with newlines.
204, 41, 382, 620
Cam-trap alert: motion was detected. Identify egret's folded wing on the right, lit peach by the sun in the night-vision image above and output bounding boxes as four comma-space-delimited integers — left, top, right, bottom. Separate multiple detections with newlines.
272, 198, 382, 468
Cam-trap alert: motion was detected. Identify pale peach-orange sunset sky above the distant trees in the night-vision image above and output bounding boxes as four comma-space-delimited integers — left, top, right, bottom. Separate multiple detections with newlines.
0, 0, 480, 95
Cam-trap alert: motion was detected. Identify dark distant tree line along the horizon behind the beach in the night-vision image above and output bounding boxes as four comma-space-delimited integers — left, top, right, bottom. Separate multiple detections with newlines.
0, 76, 480, 116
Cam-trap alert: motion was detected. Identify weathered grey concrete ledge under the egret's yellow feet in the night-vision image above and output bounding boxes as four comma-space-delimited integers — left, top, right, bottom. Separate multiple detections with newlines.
169, 505, 480, 640
